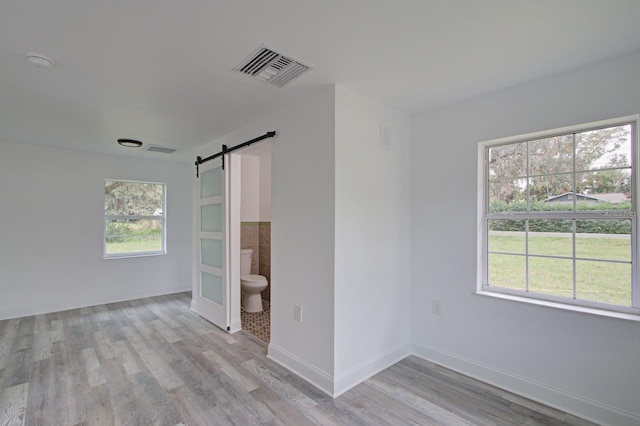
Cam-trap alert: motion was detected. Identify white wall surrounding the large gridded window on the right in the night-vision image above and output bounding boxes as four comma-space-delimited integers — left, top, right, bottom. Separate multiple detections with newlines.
411, 50, 640, 425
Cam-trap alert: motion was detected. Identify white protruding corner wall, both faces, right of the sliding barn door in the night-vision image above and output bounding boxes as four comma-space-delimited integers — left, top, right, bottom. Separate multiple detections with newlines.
208, 87, 410, 395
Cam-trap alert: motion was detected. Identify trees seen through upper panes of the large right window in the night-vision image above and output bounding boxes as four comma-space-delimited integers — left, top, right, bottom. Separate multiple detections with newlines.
489, 125, 631, 203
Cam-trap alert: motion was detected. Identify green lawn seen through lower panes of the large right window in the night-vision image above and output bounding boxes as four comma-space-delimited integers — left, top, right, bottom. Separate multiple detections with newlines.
489, 233, 631, 306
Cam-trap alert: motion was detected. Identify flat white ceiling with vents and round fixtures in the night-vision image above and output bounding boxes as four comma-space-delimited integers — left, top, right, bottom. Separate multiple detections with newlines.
0, 0, 640, 160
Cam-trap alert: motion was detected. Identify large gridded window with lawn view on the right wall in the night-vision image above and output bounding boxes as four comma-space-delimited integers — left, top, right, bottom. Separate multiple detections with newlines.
478, 116, 640, 315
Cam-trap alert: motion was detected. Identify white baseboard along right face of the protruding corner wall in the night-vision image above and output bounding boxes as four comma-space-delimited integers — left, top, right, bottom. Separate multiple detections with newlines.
332, 343, 411, 398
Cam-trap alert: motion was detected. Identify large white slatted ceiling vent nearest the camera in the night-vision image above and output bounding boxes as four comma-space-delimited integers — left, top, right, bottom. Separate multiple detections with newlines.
233, 46, 311, 87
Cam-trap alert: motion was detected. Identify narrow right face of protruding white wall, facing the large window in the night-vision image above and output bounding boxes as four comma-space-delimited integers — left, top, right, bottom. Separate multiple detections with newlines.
334, 87, 410, 394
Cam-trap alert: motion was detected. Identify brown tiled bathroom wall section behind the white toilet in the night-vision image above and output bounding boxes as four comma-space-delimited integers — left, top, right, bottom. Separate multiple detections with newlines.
240, 222, 271, 300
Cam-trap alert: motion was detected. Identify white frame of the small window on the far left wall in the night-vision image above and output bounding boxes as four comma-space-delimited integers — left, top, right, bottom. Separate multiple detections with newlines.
102, 179, 167, 260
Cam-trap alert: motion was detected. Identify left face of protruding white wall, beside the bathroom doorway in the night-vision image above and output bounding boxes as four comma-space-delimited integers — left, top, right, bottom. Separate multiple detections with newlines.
201, 86, 335, 393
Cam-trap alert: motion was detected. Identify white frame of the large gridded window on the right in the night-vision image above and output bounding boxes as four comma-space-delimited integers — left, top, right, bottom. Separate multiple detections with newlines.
476, 115, 640, 321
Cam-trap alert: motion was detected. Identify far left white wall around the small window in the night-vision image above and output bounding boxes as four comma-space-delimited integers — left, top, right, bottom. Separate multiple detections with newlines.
0, 142, 193, 319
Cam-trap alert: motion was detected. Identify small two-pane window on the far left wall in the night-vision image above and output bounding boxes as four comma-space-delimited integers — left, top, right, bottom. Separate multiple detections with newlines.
104, 180, 166, 258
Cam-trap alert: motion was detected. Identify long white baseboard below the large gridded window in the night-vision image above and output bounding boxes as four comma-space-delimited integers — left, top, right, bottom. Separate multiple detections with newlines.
411, 342, 640, 426
